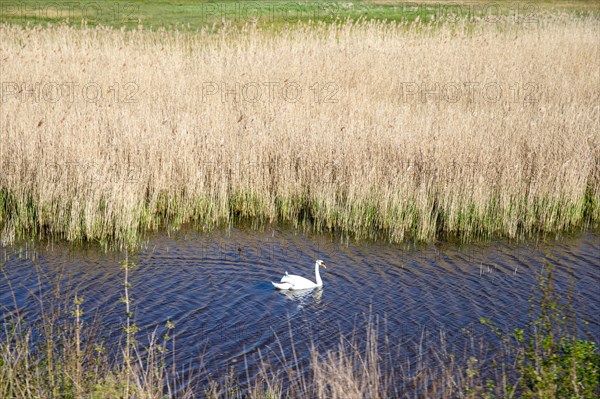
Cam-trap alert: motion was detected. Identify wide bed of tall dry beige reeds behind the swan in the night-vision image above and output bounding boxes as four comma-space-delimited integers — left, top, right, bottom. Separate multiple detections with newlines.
0, 16, 600, 245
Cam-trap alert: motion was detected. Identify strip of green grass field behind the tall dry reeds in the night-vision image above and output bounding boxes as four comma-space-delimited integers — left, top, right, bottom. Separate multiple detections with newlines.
0, 0, 600, 31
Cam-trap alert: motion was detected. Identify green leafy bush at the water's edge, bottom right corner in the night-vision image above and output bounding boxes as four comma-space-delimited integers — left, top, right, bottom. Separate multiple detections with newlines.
481, 262, 600, 399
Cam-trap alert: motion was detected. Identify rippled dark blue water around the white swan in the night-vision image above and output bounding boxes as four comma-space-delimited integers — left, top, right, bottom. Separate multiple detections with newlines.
0, 229, 600, 390
